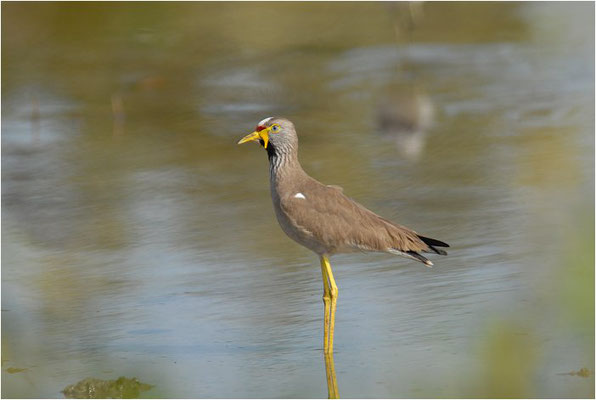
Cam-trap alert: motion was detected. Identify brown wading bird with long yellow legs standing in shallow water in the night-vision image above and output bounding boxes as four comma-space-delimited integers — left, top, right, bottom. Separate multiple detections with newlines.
238, 117, 449, 354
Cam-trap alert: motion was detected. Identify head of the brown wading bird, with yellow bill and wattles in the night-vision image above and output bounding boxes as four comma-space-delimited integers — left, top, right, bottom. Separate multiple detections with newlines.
238, 117, 298, 155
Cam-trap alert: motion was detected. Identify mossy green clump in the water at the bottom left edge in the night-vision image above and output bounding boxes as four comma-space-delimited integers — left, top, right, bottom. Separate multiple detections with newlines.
62, 376, 153, 399
